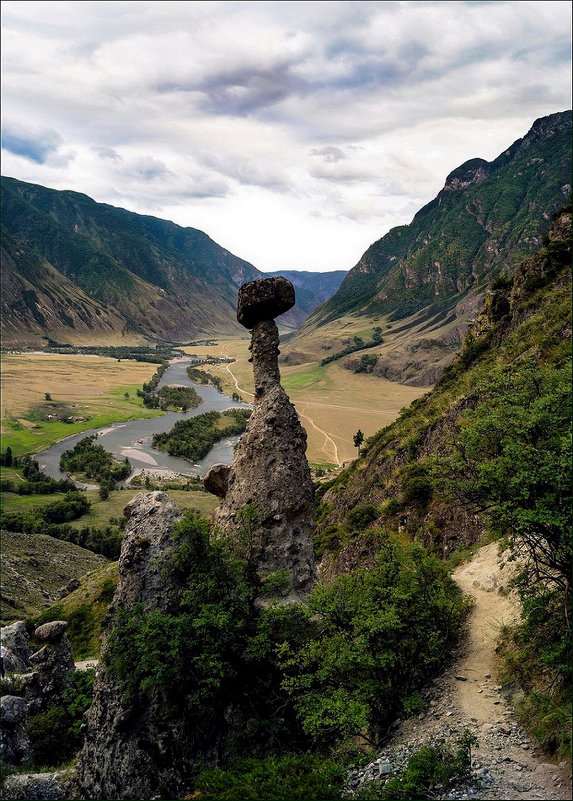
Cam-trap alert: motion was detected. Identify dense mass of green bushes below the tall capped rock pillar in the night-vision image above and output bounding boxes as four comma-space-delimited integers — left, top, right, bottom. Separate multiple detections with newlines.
104, 513, 466, 784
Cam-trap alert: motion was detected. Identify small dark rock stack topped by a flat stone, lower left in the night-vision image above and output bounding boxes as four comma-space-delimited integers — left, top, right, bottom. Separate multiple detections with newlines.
23, 620, 76, 714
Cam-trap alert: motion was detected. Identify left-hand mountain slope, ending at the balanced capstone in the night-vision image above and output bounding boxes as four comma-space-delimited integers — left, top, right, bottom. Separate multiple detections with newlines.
2, 178, 261, 340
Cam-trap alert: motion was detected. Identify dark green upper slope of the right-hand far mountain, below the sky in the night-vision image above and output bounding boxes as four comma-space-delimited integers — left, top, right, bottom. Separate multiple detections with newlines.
309, 111, 571, 324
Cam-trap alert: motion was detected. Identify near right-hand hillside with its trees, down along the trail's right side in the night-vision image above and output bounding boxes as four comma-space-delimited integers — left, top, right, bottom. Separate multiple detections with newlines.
317, 209, 573, 764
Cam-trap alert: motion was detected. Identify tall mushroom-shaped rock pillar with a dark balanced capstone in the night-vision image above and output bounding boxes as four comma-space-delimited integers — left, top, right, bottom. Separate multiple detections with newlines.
205, 277, 315, 599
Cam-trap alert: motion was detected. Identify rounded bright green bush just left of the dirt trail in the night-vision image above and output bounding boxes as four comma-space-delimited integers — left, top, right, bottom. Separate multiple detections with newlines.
274, 538, 465, 743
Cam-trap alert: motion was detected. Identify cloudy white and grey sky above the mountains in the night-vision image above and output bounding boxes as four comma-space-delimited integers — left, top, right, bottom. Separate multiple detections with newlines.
2, 0, 571, 270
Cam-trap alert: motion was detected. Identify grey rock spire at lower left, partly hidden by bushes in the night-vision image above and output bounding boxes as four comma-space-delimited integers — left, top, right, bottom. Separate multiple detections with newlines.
74, 492, 206, 799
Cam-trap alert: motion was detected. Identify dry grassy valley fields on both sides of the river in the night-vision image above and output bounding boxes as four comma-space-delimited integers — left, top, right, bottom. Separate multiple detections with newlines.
2, 340, 428, 466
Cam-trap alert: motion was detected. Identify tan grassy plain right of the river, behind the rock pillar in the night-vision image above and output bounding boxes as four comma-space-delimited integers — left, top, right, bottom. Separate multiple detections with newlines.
181, 334, 429, 466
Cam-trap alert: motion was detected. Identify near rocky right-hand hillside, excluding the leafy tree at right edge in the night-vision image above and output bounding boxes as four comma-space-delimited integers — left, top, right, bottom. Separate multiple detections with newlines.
319, 209, 571, 569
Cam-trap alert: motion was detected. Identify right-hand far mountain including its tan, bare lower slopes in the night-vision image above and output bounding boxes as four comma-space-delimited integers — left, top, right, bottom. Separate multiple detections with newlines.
289, 111, 571, 385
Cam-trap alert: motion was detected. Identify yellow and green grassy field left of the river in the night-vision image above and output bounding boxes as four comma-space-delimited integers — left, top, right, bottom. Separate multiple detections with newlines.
2, 353, 161, 456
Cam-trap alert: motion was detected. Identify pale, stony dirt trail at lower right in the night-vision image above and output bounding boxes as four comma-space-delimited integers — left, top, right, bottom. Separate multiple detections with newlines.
354, 543, 571, 801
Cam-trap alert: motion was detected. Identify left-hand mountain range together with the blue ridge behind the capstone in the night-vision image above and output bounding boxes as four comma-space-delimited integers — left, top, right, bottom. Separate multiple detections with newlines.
2, 178, 342, 345
